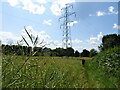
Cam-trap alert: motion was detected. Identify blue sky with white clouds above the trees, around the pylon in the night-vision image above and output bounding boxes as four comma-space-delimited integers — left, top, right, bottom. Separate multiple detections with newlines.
0, 0, 120, 52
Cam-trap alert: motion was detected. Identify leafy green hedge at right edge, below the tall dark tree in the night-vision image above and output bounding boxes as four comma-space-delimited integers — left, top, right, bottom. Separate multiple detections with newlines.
95, 46, 120, 77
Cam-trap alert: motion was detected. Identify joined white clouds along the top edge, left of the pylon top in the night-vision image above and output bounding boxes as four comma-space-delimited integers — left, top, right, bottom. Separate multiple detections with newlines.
4, 0, 75, 16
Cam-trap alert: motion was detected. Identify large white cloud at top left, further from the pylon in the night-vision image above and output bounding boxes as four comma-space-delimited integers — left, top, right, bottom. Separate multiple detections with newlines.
6, 0, 46, 14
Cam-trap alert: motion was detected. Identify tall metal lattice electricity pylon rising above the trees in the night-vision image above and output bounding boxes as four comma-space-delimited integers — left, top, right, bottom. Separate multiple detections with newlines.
59, 4, 76, 48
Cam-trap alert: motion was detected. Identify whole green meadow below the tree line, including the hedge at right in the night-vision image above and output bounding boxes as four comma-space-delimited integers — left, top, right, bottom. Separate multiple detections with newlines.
2, 47, 120, 88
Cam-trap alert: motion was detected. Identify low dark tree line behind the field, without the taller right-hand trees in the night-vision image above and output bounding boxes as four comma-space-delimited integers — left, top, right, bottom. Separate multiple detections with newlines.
2, 44, 97, 57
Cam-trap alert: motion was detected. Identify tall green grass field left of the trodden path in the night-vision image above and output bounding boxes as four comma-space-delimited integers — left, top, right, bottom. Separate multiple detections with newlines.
2, 55, 93, 88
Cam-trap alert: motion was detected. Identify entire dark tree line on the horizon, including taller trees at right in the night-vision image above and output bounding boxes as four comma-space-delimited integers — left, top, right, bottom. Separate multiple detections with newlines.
2, 34, 120, 57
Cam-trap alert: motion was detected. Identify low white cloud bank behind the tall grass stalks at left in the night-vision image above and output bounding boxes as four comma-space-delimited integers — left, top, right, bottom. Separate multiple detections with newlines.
0, 26, 62, 49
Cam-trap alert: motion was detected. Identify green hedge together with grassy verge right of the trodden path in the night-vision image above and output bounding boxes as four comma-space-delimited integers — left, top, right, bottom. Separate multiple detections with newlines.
87, 46, 120, 88
